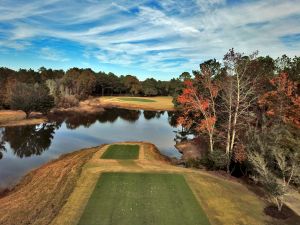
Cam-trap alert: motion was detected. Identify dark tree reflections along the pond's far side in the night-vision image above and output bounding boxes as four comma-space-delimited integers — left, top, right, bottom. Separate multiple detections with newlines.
0, 108, 177, 159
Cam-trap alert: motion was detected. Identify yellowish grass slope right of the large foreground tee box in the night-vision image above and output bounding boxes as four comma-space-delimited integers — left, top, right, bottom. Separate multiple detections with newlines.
186, 174, 268, 225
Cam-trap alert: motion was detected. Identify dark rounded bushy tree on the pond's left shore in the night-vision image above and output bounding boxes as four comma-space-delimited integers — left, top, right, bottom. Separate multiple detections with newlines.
10, 83, 54, 118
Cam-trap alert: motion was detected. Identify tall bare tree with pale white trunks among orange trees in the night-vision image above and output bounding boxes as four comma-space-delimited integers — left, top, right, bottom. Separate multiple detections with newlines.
222, 49, 257, 172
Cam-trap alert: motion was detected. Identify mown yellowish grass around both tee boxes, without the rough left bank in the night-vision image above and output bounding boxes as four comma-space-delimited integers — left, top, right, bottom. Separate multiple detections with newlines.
51, 142, 271, 225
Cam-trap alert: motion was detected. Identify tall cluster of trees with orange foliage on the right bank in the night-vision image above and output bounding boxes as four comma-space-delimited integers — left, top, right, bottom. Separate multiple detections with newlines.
175, 49, 300, 211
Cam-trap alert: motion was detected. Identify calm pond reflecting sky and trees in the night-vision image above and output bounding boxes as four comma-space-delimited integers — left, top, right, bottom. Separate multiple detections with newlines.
0, 108, 180, 188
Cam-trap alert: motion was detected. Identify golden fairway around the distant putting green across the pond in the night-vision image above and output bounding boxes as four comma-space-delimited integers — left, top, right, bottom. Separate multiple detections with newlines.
99, 96, 174, 111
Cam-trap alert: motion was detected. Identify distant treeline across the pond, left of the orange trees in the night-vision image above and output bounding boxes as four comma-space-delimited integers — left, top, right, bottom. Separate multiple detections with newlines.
0, 67, 183, 114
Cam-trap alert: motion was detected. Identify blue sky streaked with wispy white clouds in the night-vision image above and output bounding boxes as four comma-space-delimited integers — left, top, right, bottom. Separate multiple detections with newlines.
0, 0, 300, 80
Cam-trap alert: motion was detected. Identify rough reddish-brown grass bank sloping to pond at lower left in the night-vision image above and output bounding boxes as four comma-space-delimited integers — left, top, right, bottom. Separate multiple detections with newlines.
0, 148, 96, 225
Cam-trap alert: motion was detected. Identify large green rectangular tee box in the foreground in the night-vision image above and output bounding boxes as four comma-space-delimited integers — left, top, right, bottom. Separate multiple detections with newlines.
79, 173, 210, 225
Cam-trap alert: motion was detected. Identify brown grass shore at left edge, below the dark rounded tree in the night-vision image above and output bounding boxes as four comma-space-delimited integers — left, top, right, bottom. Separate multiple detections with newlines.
0, 110, 47, 127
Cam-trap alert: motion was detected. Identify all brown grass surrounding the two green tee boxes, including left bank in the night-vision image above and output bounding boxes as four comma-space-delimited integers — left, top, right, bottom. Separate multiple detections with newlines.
0, 142, 298, 225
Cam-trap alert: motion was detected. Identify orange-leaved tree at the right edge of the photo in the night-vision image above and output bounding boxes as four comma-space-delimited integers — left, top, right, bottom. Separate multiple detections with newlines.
258, 73, 300, 128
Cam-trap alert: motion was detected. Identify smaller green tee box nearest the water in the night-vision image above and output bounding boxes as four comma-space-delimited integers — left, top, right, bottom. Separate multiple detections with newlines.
101, 145, 140, 159
